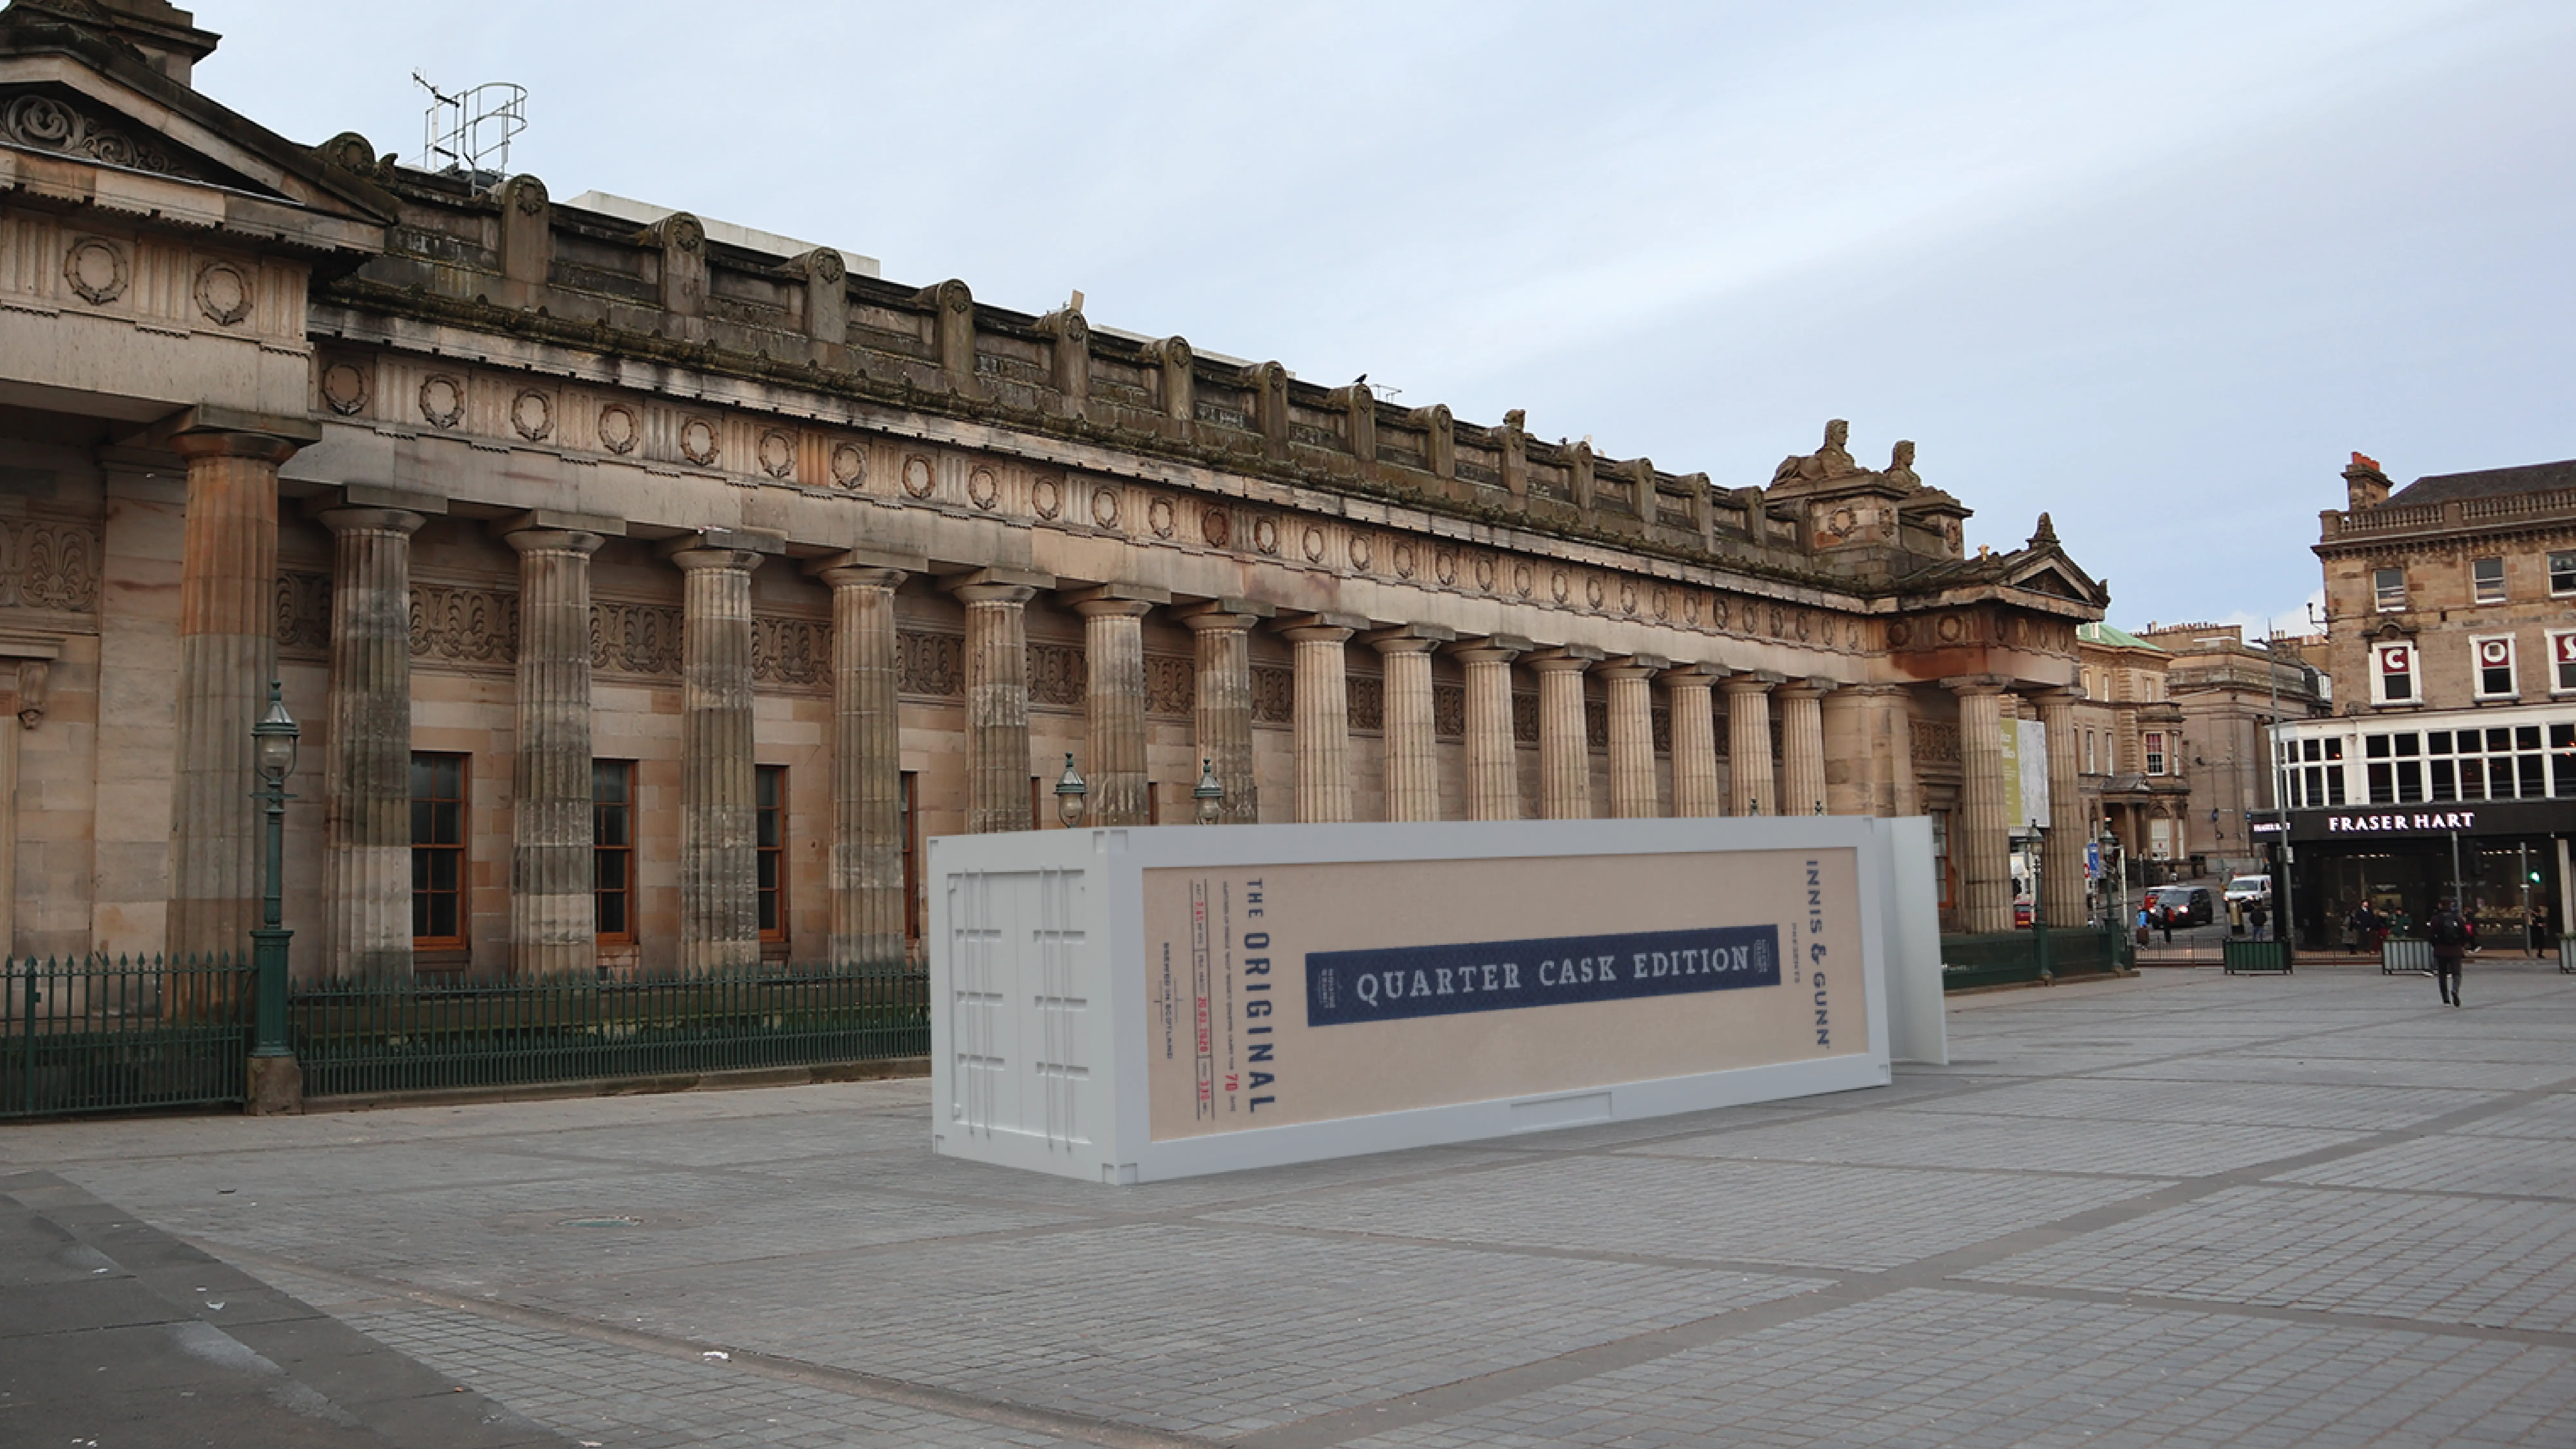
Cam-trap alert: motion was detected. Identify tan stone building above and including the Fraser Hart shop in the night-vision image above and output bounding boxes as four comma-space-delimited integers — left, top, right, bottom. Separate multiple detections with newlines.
2277, 453, 2576, 942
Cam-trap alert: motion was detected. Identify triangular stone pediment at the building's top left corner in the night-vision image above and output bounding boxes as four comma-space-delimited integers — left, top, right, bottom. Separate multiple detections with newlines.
0, 5, 397, 238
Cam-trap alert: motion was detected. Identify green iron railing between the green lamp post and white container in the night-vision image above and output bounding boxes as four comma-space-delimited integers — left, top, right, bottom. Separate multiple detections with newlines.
288, 968, 930, 1096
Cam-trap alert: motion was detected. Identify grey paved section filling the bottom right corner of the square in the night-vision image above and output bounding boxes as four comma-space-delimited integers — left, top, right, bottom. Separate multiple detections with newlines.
1353, 1289, 2576, 1449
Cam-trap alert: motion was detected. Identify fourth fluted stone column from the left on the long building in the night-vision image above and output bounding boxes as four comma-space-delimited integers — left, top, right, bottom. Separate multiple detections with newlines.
670, 535, 760, 975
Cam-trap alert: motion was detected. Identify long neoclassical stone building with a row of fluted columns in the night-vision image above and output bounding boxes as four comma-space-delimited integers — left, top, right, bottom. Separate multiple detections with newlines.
0, 0, 2105, 975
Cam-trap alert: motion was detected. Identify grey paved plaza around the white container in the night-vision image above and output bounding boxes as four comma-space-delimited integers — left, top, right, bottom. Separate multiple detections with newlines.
0, 963, 2576, 1449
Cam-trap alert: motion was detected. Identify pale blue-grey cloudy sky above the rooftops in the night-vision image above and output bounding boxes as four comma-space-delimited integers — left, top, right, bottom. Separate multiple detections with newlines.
196, 0, 2576, 631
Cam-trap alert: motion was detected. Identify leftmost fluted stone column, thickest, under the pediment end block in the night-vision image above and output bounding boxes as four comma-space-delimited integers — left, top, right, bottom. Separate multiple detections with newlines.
170, 432, 296, 955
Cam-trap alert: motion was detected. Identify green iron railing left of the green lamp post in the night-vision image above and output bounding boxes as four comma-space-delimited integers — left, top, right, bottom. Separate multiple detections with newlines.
0, 955, 252, 1117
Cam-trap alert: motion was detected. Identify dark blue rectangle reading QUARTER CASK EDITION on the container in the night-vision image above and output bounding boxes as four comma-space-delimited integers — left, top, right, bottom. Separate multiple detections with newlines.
1306, 927, 1780, 1027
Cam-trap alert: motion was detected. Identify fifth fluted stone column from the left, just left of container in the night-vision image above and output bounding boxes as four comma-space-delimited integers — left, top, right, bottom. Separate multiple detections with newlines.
819, 561, 904, 965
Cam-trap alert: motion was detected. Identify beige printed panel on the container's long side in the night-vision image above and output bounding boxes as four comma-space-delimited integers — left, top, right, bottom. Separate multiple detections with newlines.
1144, 849, 1870, 1140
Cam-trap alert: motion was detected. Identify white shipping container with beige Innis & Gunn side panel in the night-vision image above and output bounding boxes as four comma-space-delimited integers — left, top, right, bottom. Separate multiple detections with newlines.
932, 821, 1888, 1181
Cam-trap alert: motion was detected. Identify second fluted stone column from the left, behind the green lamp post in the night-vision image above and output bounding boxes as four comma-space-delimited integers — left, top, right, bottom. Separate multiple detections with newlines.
322, 507, 425, 978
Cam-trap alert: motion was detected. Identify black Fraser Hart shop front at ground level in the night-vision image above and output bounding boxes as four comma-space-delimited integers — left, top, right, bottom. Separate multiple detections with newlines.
2288, 800, 2576, 950
